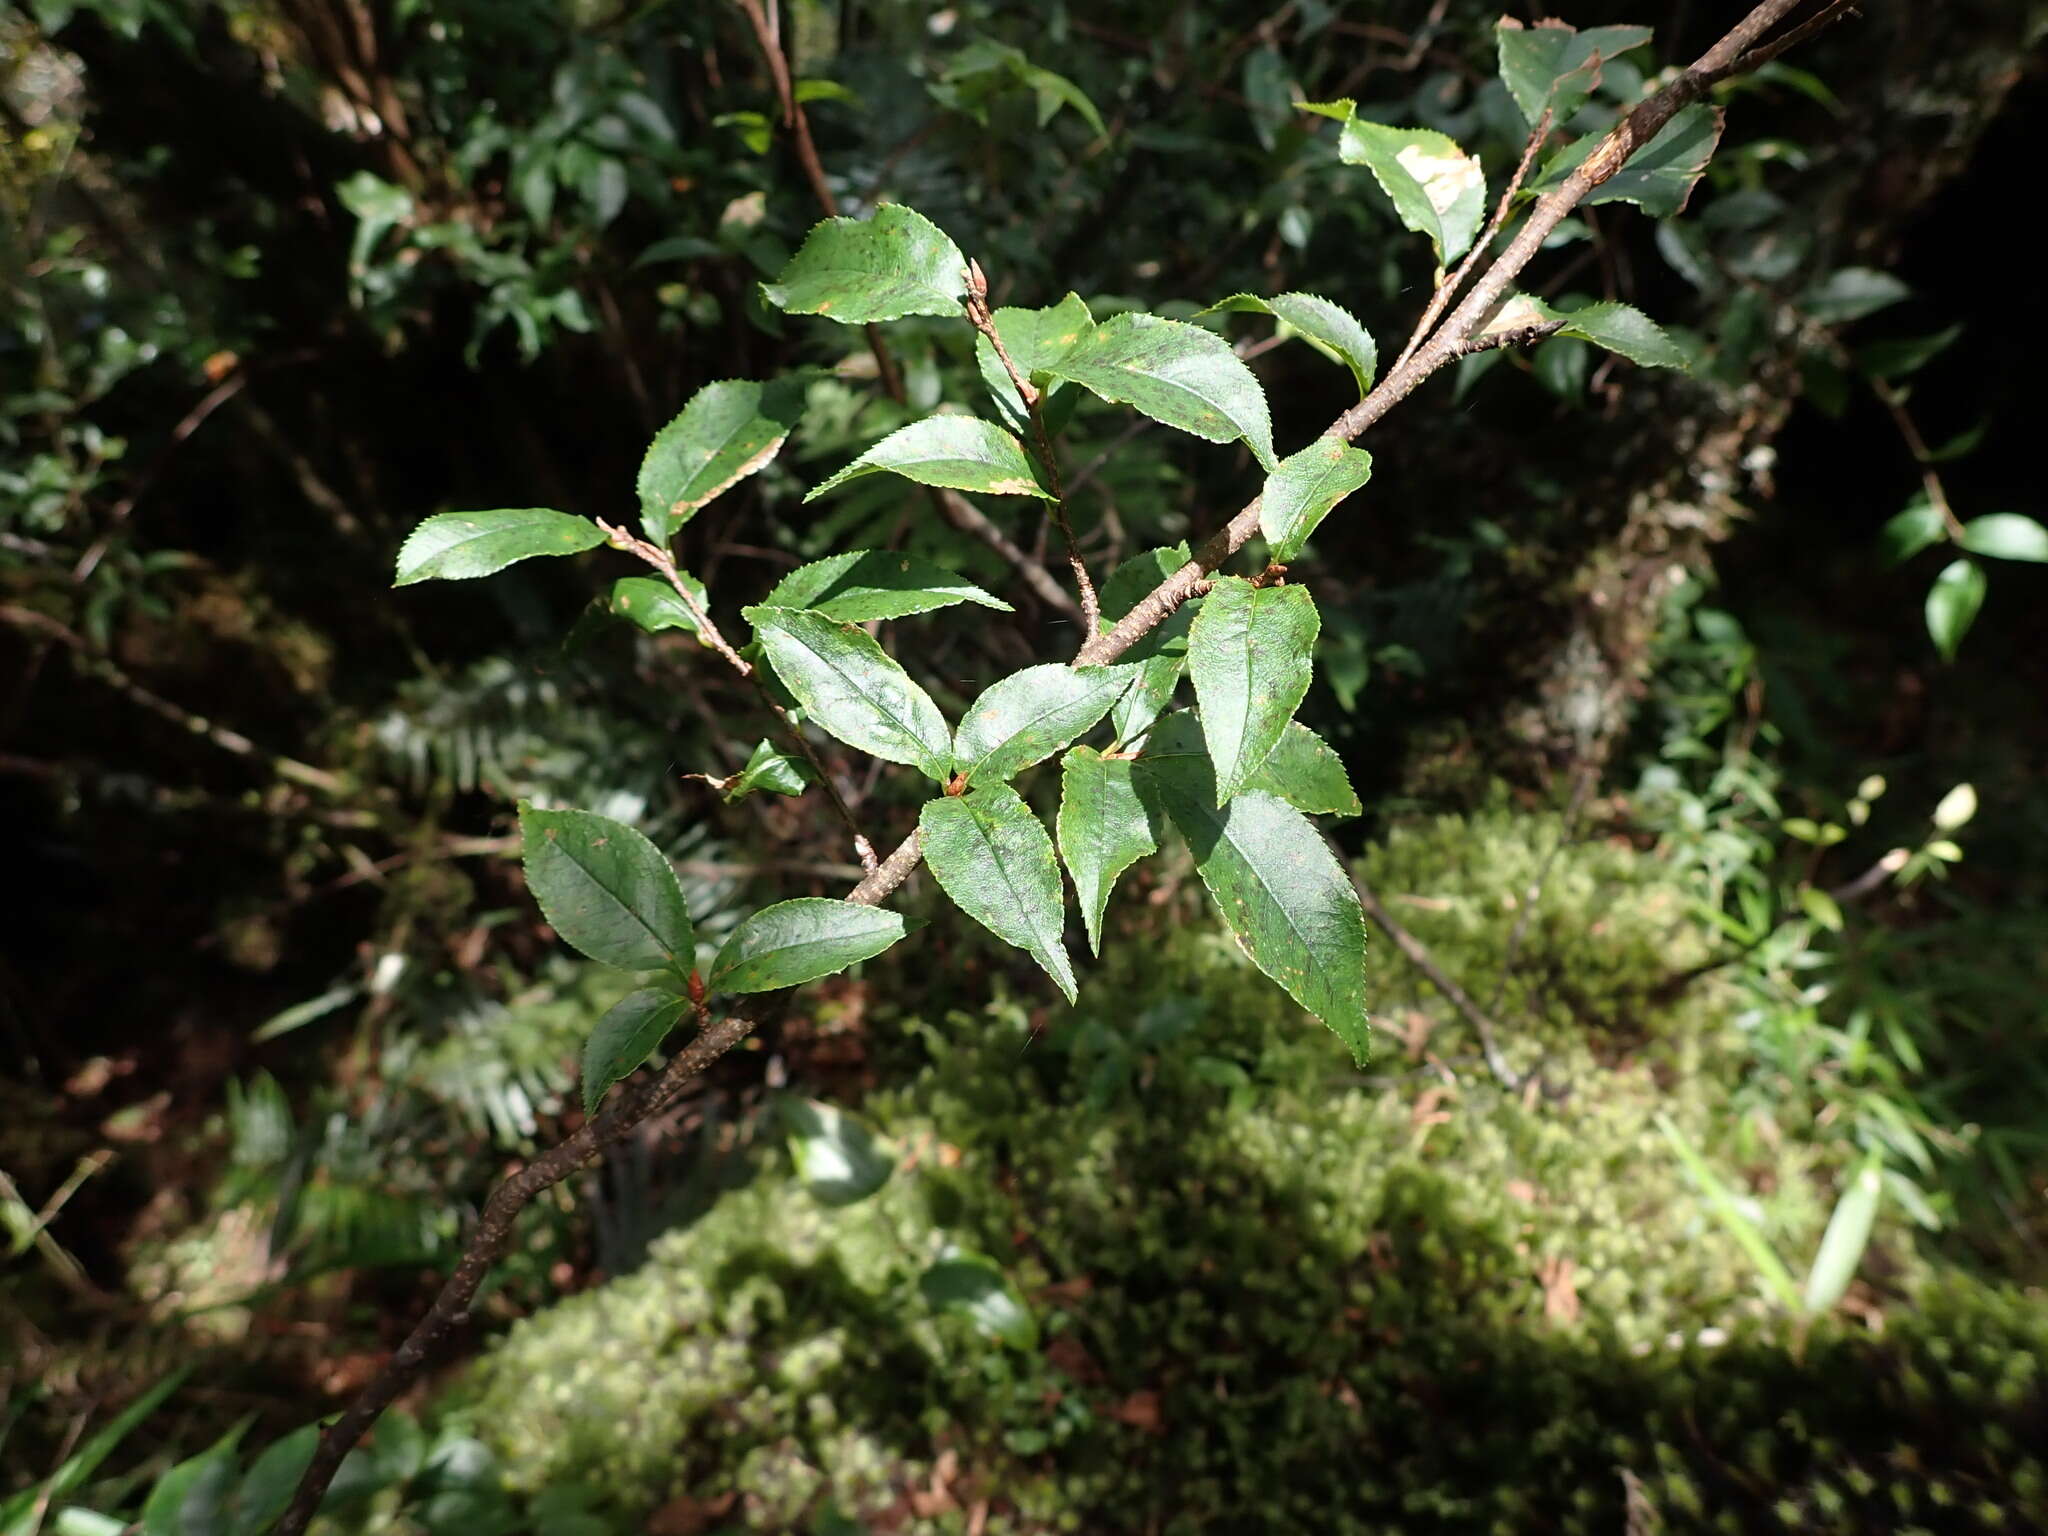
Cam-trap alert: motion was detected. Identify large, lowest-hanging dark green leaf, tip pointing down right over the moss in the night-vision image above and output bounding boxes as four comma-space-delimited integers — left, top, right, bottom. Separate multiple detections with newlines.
1135, 715, 1370, 1065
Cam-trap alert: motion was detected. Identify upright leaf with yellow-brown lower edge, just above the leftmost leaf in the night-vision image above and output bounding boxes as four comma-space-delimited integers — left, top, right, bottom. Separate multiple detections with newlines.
635, 375, 811, 545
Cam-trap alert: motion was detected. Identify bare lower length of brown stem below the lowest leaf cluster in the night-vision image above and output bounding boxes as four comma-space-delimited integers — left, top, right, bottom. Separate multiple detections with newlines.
274, 1014, 754, 1536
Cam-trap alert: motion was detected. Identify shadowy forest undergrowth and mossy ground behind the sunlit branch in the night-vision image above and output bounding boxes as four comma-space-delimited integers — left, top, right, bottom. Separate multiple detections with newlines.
0, 0, 2048, 1536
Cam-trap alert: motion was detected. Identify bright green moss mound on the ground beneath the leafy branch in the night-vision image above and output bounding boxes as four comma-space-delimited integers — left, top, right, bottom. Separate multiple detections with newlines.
463, 811, 2048, 1532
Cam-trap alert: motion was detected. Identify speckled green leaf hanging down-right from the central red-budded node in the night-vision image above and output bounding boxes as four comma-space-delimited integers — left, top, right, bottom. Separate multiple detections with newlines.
918, 784, 1075, 1004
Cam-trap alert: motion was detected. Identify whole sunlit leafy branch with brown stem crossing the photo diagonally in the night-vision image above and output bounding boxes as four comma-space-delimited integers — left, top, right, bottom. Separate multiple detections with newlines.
239, 0, 1875, 1534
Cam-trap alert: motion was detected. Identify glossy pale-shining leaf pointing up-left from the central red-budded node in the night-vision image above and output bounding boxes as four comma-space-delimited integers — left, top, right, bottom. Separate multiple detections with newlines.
745, 604, 952, 780
